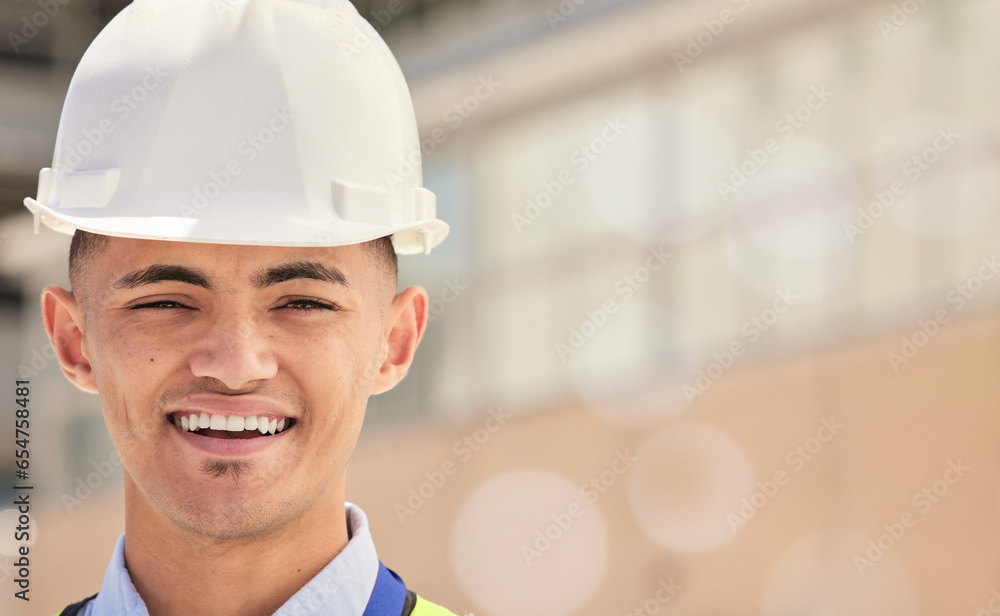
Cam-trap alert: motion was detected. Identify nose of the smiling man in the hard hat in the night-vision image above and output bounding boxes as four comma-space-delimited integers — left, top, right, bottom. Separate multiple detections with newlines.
188, 311, 278, 390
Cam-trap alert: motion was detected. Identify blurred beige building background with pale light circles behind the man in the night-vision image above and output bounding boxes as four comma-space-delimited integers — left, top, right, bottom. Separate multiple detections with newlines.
0, 0, 1000, 616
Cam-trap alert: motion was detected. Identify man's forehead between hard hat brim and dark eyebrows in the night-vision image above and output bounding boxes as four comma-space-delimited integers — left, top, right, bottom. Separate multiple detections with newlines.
88, 237, 377, 291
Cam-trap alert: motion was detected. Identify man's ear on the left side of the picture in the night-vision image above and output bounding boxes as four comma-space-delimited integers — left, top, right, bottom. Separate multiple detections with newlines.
42, 286, 97, 394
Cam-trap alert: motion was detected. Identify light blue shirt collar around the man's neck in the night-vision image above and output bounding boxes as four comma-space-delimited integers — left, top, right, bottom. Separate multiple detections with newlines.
80, 503, 378, 616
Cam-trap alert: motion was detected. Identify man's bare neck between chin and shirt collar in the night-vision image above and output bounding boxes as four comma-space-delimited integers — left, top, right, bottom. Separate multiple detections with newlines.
124, 473, 348, 616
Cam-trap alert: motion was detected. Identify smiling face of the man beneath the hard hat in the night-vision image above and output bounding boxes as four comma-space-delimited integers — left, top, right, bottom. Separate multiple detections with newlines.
53, 238, 414, 538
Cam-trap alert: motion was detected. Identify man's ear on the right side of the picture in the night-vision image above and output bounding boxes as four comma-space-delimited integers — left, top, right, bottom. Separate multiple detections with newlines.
372, 287, 427, 394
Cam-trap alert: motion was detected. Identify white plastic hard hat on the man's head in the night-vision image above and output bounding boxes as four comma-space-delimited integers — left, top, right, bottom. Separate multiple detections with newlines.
24, 0, 448, 254
